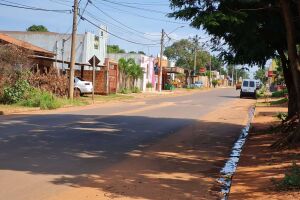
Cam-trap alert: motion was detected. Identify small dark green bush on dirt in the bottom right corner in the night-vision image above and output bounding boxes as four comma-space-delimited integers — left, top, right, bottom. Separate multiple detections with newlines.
276, 163, 300, 190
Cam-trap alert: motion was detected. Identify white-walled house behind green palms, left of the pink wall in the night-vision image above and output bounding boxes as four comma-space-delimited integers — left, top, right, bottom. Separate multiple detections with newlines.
108, 53, 156, 91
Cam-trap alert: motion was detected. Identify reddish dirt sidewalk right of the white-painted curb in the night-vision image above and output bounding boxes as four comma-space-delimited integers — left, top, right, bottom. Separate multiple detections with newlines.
229, 102, 300, 200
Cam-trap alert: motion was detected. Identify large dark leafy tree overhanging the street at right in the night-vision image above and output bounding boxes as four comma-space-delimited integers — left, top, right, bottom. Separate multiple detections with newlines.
169, 0, 300, 146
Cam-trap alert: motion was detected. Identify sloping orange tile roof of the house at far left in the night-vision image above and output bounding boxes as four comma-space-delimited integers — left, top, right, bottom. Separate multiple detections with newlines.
0, 33, 55, 57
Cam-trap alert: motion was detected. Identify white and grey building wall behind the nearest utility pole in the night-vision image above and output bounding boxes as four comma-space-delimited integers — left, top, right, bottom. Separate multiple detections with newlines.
0, 27, 108, 70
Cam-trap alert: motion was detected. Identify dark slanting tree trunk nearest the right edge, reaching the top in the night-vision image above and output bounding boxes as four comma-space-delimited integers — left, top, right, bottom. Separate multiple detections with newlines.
279, 0, 300, 114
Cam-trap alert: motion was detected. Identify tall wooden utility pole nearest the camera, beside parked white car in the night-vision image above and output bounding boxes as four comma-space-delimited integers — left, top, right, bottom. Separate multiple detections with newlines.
69, 0, 78, 99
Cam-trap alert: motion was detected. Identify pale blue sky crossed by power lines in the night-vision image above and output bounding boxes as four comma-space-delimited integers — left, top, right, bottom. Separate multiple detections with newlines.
0, 0, 258, 76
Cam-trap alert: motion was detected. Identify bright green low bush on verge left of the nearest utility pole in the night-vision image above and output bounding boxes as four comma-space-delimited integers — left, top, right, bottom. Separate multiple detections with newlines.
19, 88, 62, 110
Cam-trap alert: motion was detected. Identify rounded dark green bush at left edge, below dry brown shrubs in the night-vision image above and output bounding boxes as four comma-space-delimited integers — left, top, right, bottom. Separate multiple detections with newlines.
1, 80, 30, 104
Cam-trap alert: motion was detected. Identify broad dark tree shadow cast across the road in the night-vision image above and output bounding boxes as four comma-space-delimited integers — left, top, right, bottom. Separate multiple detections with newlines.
0, 115, 242, 200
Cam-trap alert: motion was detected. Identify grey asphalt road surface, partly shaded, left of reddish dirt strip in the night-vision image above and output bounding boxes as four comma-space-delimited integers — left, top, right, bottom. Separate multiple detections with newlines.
0, 89, 244, 200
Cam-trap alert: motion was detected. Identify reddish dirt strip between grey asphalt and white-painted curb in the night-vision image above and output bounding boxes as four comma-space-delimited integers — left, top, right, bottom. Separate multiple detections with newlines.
51, 99, 253, 200
